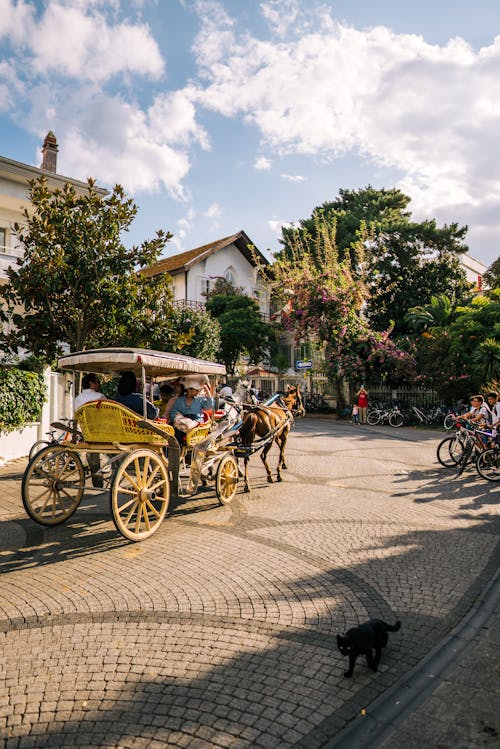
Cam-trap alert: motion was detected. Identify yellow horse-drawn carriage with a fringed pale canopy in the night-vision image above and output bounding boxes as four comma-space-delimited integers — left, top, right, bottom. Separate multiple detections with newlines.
22, 348, 239, 541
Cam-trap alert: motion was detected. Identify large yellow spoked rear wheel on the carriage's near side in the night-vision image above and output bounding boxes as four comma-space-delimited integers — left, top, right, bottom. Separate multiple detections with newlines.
111, 449, 170, 541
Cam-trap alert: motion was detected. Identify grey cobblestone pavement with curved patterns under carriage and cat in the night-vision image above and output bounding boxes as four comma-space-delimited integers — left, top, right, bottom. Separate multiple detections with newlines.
0, 418, 500, 749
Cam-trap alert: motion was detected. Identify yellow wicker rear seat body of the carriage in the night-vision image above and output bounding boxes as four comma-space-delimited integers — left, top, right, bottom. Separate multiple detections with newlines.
75, 400, 174, 445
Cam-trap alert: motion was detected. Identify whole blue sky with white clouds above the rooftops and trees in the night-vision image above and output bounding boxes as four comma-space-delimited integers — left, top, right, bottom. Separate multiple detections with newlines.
0, 0, 500, 265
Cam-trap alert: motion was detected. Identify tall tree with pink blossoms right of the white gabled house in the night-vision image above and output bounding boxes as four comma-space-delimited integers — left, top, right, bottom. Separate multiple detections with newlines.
269, 216, 414, 404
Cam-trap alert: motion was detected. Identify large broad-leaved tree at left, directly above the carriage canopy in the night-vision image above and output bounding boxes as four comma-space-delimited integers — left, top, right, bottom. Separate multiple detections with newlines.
0, 177, 175, 362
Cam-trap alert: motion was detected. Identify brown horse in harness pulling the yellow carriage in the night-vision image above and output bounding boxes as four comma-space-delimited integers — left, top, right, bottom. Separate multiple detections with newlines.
239, 386, 305, 492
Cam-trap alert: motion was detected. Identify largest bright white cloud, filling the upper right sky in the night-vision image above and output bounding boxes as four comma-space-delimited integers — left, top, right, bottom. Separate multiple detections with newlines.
191, 2, 500, 253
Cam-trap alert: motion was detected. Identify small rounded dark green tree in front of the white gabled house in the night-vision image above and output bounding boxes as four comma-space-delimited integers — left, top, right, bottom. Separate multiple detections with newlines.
206, 293, 276, 374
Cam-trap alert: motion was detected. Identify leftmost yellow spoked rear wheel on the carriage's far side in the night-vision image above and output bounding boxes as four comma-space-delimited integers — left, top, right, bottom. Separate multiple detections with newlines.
21, 446, 85, 525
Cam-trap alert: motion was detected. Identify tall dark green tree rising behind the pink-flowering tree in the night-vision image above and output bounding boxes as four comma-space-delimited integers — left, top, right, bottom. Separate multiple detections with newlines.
281, 186, 470, 336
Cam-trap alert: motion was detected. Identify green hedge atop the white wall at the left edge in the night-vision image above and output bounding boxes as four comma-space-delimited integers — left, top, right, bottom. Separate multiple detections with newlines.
0, 367, 47, 434
